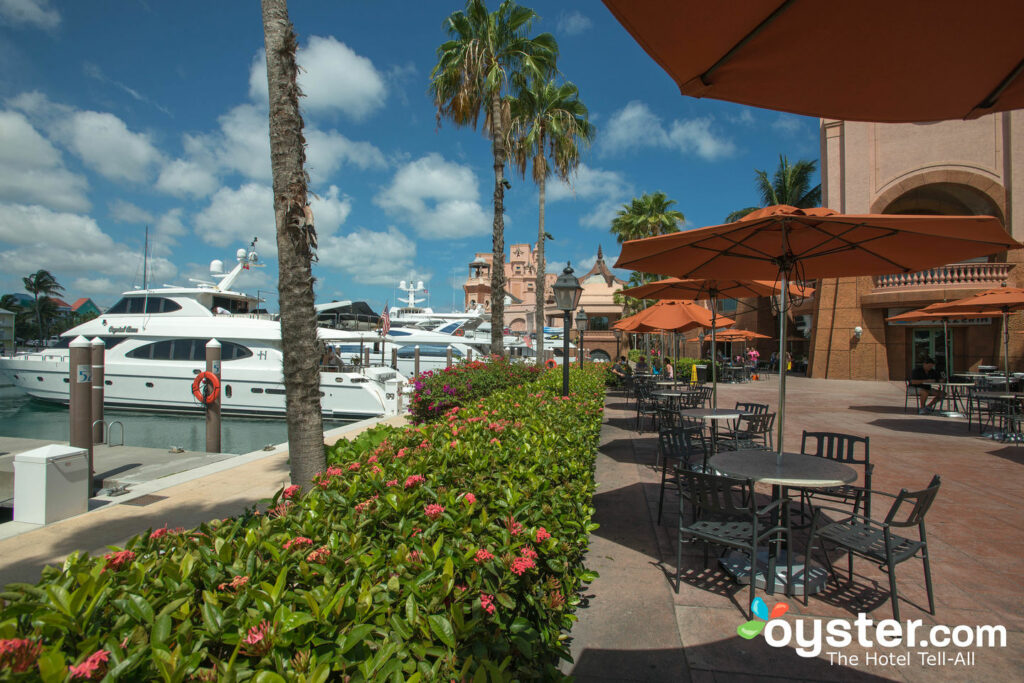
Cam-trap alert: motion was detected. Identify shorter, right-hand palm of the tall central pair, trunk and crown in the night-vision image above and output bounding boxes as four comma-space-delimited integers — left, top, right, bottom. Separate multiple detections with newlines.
509, 80, 594, 366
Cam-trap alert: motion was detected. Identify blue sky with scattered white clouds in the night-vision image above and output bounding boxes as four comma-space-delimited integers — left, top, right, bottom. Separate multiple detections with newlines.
0, 0, 818, 309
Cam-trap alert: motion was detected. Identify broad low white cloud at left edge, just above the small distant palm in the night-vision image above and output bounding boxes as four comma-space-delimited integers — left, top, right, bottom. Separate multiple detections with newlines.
0, 205, 177, 288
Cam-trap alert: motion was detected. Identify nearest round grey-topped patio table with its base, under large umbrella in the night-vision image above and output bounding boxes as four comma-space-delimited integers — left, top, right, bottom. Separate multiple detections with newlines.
710, 449, 857, 595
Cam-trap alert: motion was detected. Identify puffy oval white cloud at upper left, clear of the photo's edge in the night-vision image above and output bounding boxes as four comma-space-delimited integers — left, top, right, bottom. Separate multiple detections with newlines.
57, 112, 161, 182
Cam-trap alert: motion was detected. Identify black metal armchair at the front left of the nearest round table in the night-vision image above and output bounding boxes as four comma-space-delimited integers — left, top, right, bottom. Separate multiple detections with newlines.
676, 471, 793, 618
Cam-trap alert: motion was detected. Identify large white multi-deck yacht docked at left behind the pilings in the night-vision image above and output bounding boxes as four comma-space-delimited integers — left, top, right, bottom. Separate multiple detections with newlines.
0, 241, 406, 418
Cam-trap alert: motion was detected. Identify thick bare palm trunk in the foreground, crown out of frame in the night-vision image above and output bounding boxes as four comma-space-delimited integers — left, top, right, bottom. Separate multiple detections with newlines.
262, 0, 327, 488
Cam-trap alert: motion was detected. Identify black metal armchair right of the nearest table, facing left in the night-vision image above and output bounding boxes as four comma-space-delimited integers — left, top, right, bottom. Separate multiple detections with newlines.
804, 474, 941, 622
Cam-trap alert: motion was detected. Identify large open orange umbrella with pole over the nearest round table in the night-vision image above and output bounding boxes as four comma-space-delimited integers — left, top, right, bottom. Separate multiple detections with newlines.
615, 206, 1024, 458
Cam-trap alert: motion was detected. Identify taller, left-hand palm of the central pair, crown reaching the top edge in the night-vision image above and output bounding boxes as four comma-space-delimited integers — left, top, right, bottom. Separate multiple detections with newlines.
430, 0, 558, 353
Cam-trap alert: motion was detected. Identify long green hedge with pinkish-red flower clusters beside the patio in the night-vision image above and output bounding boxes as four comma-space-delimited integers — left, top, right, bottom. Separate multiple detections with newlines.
0, 360, 603, 681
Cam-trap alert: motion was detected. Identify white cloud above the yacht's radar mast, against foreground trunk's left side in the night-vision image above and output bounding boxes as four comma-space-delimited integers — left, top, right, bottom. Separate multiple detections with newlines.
196, 182, 278, 256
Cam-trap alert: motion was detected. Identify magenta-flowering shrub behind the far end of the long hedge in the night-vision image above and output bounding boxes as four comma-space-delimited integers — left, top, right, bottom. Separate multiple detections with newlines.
410, 355, 544, 422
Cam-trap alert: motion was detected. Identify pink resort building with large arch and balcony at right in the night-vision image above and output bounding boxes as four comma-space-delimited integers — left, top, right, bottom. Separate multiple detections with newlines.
737, 111, 1024, 380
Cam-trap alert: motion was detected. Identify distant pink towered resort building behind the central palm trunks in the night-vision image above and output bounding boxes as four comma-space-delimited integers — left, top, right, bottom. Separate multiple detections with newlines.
463, 244, 626, 359
